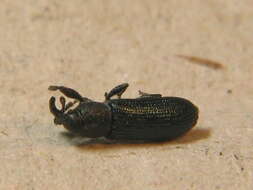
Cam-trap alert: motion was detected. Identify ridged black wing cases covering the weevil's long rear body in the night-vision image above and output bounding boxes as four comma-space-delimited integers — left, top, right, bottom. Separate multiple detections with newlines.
107, 97, 198, 141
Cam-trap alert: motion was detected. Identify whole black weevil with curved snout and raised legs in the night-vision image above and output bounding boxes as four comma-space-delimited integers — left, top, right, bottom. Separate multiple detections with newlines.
49, 83, 198, 141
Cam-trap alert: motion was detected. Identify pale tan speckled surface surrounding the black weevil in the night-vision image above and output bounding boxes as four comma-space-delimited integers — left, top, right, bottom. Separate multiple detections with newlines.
0, 0, 253, 190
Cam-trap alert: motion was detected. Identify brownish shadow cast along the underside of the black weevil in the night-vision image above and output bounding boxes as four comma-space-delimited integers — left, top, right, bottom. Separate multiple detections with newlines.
60, 129, 211, 149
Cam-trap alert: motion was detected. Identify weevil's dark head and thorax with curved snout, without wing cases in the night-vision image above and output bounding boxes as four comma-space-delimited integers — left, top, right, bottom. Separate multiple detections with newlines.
49, 97, 111, 138
